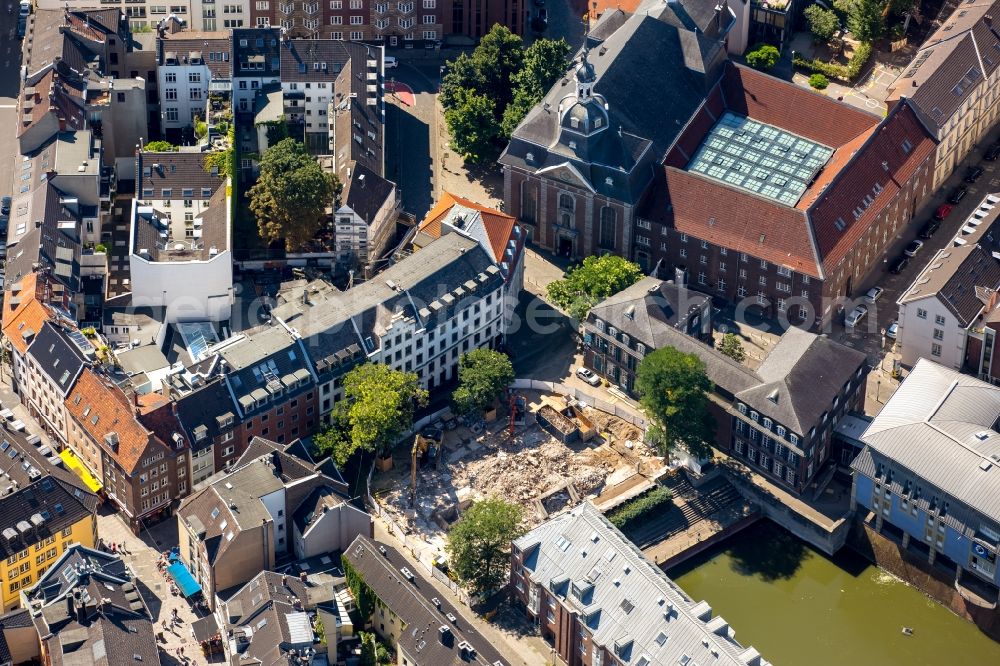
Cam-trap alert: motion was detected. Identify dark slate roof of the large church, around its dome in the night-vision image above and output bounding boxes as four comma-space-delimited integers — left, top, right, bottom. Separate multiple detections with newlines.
500, 3, 726, 195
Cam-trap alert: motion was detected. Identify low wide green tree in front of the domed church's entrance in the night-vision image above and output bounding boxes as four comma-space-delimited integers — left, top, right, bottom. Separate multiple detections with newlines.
546, 254, 642, 321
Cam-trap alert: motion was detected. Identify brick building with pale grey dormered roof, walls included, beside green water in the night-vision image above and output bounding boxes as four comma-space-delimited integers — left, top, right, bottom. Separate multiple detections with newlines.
511, 502, 770, 666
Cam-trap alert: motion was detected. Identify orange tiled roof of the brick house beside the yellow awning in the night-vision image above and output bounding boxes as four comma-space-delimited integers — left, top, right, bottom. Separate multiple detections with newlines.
66, 368, 162, 474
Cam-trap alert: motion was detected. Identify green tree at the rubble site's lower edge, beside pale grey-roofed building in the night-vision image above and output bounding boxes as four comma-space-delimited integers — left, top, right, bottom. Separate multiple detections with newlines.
447, 497, 524, 594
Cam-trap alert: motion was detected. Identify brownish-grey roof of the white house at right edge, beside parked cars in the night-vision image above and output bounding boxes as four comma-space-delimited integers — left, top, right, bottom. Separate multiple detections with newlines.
896, 191, 1000, 327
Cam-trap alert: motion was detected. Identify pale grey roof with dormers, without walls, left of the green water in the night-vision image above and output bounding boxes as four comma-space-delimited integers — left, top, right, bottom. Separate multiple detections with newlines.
514, 502, 768, 666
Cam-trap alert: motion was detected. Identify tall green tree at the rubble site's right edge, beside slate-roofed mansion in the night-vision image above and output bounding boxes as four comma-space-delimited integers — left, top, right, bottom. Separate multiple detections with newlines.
635, 347, 715, 458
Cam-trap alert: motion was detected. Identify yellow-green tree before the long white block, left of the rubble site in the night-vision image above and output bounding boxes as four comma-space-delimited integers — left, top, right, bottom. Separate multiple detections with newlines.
317, 363, 428, 466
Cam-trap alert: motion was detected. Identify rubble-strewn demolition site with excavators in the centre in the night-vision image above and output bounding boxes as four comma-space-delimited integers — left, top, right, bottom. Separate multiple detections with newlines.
372, 391, 667, 549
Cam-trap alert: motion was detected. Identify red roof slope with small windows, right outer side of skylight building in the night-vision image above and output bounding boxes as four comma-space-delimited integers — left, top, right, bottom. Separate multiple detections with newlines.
809, 103, 935, 270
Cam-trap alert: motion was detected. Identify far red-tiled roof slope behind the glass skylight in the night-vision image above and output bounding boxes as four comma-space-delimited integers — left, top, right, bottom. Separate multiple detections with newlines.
722, 64, 879, 148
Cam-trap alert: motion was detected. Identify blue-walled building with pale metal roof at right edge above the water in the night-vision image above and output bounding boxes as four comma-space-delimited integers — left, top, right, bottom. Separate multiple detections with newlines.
851, 359, 1000, 609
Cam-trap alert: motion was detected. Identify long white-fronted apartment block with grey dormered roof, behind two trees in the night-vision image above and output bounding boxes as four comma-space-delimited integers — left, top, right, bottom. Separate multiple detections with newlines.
272, 234, 505, 419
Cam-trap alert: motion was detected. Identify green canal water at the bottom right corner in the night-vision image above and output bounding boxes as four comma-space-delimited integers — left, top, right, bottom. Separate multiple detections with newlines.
667, 521, 1000, 666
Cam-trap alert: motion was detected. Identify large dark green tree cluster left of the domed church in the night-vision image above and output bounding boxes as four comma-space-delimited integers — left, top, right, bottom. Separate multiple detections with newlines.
439, 24, 571, 161
